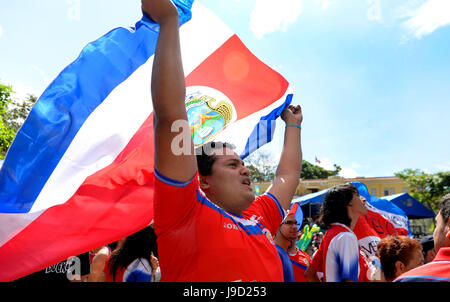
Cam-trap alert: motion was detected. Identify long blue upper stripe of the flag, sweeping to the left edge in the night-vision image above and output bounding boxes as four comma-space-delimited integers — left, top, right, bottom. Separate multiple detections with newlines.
0, 0, 193, 213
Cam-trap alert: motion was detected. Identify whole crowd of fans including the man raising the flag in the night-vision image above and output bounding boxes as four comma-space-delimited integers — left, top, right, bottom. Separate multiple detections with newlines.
14, 0, 450, 282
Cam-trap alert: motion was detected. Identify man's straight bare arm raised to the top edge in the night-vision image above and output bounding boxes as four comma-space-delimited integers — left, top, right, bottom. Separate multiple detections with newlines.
142, 0, 197, 182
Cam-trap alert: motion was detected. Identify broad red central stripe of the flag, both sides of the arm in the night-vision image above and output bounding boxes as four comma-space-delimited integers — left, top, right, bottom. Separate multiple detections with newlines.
0, 36, 289, 281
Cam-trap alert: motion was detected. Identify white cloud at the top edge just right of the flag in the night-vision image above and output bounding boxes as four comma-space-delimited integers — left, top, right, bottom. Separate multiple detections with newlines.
250, 0, 302, 39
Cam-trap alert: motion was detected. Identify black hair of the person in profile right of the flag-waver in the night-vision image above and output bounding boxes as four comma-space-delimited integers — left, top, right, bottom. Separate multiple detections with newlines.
319, 184, 359, 228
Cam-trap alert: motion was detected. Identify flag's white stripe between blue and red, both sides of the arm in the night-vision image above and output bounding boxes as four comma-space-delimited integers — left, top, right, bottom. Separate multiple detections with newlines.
30, 5, 232, 212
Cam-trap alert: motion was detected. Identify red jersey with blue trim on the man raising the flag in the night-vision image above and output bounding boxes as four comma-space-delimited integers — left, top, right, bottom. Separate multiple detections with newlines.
154, 171, 285, 282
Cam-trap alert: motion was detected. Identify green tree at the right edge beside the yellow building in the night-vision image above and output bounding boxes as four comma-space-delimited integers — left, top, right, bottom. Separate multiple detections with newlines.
394, 169, 450, 212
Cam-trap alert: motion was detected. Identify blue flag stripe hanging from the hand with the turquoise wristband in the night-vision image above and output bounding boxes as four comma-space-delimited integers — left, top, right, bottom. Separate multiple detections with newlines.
240, 94, 293, 159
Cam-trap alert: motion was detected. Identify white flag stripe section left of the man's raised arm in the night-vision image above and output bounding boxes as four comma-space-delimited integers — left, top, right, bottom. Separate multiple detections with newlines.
30, 59, 152, 212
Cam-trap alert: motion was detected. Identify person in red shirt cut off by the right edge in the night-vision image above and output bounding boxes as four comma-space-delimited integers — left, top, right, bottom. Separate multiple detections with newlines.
394, 193, 450, 282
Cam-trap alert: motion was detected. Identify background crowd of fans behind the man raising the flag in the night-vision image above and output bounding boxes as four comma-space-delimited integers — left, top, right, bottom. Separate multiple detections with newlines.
16, 191, 450, 282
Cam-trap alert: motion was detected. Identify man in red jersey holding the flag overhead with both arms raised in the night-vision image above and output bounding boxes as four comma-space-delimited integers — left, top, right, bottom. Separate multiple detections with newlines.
146, 0, 303, 281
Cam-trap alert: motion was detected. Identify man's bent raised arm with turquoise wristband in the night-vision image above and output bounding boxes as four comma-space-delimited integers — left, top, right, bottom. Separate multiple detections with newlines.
268, 105, 303, 210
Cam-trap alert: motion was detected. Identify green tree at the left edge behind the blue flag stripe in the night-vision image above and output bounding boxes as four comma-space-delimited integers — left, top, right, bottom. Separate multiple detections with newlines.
0, 83, 37, 159
